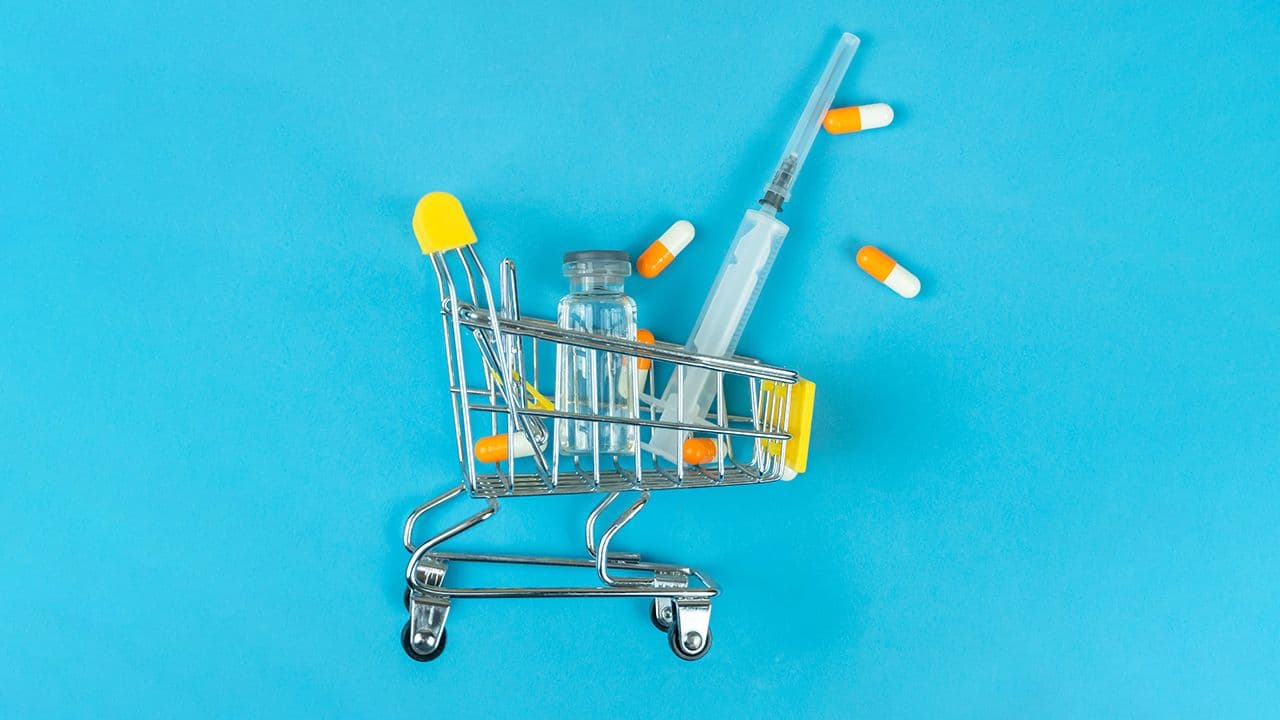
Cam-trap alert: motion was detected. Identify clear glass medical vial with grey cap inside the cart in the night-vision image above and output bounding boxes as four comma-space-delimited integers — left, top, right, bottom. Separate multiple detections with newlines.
556, 250, 637, 455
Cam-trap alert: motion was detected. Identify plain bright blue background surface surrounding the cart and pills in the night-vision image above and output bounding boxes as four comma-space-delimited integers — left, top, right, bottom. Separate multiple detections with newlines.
0, 1, 1280, 717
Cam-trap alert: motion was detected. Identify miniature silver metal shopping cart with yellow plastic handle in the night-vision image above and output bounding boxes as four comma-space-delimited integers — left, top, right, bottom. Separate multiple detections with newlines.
401, 193, 813, 661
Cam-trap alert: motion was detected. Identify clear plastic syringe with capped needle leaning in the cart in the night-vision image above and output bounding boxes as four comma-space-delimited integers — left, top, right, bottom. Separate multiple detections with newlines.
649, 32, 859, 462
